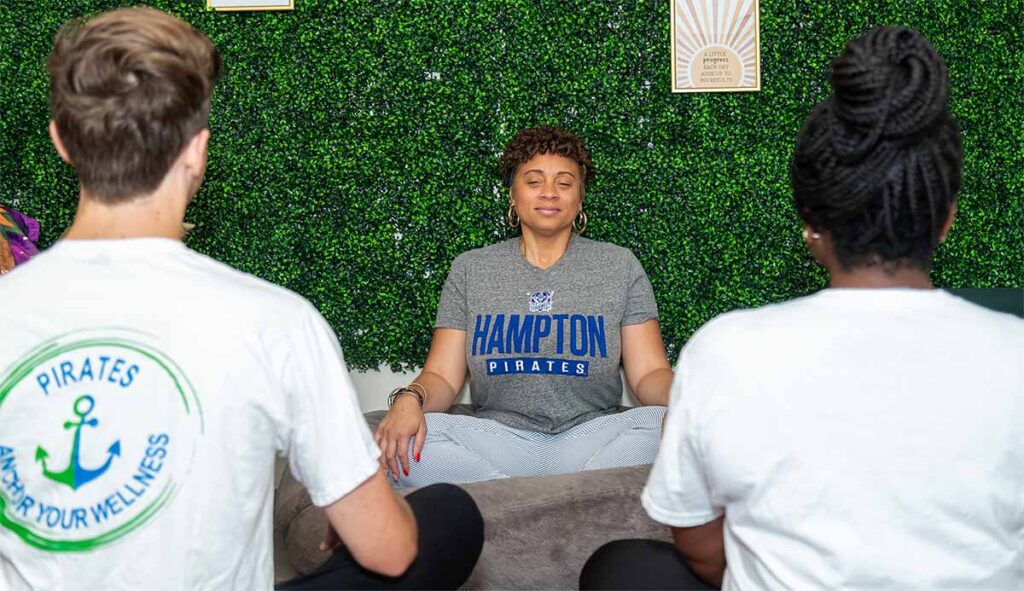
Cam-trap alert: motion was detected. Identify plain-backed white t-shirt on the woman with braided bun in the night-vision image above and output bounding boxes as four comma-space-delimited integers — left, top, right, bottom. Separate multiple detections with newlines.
642, 289, 1024, 590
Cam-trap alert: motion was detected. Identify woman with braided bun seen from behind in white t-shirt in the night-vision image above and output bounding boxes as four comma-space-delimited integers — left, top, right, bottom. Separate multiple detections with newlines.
581, 27, 1024, 589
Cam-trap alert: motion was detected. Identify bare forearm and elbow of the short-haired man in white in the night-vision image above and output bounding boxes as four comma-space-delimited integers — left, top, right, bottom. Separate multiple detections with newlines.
324, 470, 418, 577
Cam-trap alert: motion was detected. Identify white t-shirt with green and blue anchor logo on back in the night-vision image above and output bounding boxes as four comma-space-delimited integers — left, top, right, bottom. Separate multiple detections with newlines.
0, 239, 379, 589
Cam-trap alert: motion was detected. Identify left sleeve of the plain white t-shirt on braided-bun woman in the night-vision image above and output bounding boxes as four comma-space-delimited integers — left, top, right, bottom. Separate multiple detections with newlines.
640, 340, 723, 527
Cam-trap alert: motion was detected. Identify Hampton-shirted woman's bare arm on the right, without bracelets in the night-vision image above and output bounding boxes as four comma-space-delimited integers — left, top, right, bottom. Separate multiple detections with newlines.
622, 320, 673, 407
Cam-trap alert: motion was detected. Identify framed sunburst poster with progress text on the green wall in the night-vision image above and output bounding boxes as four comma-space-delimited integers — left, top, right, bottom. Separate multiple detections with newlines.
672, 0, 761, 92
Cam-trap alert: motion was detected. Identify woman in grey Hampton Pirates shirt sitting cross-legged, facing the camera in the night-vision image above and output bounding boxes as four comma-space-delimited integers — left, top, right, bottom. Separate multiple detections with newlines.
376, 127, 672, 487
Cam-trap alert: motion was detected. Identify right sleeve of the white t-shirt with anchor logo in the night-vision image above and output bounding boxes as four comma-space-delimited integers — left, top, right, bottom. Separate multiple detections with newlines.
283, 306, 380, 507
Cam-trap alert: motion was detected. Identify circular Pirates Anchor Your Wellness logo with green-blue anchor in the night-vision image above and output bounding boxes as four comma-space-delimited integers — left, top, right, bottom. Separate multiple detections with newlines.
0, 330, 203, 552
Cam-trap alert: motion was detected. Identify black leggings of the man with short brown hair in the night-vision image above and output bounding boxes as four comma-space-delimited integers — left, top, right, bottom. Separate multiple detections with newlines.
276, 484, 483, 590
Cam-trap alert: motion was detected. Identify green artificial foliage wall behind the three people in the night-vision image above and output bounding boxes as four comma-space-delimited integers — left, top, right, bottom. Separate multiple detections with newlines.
0, 0, 1024, 368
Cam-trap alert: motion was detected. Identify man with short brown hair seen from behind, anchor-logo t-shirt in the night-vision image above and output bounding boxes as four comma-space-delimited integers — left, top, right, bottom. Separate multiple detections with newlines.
0, 8, 483, 589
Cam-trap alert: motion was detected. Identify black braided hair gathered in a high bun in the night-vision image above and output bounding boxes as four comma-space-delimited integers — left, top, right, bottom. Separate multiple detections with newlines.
791, 27, 964, 269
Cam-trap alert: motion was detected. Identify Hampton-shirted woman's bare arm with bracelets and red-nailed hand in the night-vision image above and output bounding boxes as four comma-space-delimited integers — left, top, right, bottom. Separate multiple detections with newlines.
374, 329, 467, 481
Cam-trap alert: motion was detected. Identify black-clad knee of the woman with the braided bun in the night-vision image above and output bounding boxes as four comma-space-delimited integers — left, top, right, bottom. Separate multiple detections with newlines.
580, 540, 718, 591
